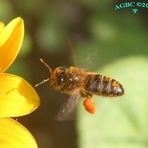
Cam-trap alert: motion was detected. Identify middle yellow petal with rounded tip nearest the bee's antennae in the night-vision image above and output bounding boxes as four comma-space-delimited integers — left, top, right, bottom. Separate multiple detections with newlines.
0, 73, 40, 118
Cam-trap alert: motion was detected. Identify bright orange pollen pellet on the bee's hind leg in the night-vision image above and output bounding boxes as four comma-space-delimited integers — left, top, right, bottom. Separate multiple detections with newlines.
83, 98, 96, 113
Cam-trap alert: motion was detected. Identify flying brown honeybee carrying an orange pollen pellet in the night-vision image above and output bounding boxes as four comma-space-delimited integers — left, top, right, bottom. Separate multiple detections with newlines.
35, 59, 124, 119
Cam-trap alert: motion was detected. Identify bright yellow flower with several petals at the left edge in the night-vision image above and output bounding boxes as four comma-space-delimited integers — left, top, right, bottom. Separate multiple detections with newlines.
0, 17, 40, 148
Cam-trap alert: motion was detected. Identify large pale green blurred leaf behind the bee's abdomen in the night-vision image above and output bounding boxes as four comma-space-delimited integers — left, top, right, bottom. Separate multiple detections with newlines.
77, 56, 148, 148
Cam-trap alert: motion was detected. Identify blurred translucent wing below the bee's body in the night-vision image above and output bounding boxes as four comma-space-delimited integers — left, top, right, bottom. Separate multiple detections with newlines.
55, 94, 80, 121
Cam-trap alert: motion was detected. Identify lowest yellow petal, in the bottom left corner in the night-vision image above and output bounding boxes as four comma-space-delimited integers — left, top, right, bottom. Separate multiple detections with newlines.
0, 118, 37, 148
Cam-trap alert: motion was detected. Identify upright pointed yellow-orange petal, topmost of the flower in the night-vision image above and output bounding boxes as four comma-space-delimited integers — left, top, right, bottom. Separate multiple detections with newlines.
0, 17, 24, 72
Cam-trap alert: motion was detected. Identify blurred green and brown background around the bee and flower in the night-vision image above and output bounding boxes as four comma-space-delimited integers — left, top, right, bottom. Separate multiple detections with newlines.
0, 0, 148, 148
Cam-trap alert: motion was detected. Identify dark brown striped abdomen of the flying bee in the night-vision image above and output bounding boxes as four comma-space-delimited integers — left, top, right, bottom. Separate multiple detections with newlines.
85, 74, 124, 96
